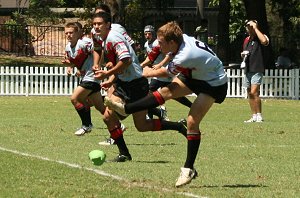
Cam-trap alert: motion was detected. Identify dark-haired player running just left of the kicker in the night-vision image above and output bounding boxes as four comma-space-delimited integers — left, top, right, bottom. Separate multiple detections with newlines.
93, 12, 186, 162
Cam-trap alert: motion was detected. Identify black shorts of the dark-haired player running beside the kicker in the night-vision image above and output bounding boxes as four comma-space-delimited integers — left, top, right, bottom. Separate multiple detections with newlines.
113, 77, 149, 103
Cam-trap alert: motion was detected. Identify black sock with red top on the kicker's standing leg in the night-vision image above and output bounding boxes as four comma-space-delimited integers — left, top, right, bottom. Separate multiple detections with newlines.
184, 131, 201, 169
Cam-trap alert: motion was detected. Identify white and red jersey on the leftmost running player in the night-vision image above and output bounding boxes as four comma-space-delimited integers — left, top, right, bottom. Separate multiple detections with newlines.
65, 37, 100, 82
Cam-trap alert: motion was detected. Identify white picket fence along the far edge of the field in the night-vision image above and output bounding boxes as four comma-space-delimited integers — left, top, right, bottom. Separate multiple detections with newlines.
0, 66, 299, 100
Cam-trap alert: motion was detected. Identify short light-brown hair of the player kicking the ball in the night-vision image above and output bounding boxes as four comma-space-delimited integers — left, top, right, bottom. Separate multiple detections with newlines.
157, 21, 183, 45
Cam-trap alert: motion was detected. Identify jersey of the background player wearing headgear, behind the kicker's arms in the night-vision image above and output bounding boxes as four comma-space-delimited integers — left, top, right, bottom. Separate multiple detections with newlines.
144, 39, 173, 82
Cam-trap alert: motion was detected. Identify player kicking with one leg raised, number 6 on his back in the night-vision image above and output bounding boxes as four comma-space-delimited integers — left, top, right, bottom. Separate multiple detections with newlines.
104, 22, 227, 187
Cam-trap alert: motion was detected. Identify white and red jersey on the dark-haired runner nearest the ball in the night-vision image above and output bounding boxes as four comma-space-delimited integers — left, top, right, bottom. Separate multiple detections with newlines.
102, 30, 143, 82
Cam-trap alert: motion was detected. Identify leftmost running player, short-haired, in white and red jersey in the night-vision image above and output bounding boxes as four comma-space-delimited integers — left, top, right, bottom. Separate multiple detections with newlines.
62, 23, 105, 135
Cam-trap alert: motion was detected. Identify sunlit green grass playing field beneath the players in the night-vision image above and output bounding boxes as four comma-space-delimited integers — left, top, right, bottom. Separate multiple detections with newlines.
0, 97, 300, 198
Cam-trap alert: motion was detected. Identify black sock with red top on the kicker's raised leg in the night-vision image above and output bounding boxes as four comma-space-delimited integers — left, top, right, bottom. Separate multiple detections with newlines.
125, 91, 165, 114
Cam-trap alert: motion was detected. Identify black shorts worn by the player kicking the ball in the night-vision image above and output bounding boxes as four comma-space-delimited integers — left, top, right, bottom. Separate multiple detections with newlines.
178, 74, 227, 103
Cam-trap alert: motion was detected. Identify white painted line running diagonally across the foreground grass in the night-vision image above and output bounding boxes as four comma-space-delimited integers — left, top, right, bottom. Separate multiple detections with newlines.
0, 146, 207, 198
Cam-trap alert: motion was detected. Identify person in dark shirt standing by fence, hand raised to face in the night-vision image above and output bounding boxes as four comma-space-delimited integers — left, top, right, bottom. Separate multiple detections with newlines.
241, 20, 269, 123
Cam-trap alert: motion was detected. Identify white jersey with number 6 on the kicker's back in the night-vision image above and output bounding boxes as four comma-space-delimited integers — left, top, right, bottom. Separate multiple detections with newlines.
167, 34, 227, 86
